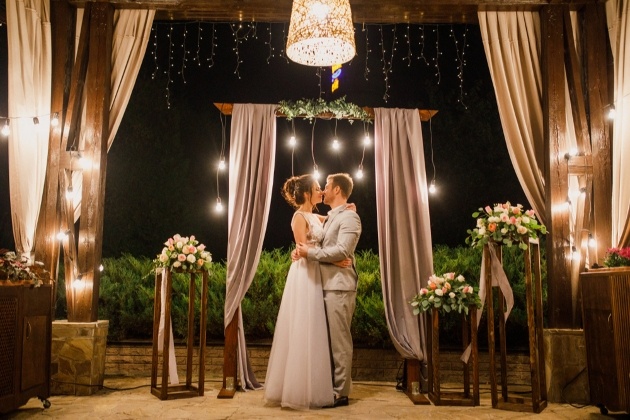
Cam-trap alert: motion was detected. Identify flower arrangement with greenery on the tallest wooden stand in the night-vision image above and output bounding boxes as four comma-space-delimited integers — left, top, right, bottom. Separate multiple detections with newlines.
466, 201, 547, 249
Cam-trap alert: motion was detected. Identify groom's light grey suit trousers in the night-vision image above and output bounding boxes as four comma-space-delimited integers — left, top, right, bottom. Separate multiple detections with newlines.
324, 290, 357, 397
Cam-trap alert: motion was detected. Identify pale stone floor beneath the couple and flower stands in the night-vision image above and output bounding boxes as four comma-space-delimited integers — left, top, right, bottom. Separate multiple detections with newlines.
0, 377, 628, 420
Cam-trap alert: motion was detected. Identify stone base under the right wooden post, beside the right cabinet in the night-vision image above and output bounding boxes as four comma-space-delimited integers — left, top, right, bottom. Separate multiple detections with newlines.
543, 329, 590, 404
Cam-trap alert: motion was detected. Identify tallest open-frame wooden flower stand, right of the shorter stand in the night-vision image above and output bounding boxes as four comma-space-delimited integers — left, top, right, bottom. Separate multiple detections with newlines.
482, 239, 547, 413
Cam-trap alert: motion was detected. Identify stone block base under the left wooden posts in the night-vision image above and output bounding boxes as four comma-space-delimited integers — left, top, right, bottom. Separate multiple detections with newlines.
50, 320, 109, 395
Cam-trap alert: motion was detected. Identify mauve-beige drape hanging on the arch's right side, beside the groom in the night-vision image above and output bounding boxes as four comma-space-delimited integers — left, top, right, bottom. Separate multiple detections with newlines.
374, 108, 433, 361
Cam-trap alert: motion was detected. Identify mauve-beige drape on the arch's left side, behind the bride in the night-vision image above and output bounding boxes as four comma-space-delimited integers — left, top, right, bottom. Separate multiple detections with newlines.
224, 104, 278, 389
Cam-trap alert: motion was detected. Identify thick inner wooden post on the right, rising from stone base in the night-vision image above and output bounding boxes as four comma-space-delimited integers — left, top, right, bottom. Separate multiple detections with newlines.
540, 5, 573, 328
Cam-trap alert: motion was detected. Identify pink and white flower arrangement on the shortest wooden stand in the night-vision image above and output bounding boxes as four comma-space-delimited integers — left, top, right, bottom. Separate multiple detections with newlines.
410, 273, 481, 315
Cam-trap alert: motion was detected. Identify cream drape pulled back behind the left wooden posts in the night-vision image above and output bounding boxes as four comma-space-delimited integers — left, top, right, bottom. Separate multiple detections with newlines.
72, 8, 155, 220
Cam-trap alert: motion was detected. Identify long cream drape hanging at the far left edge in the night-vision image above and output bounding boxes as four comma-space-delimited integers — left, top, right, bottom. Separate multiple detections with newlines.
6, 0, 51, 261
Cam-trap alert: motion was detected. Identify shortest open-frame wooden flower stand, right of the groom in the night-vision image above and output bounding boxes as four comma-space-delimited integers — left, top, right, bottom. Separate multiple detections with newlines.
427, 307, 479, 406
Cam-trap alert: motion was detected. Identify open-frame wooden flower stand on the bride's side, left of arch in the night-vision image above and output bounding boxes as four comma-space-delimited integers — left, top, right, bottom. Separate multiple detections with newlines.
151, 269, 208, 400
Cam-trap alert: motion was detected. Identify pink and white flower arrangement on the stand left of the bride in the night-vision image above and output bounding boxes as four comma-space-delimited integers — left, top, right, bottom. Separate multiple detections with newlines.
153, 234, 212, 272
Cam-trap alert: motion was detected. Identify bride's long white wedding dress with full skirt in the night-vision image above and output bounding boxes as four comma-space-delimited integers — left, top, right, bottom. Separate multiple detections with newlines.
265, 211, 334, 409
